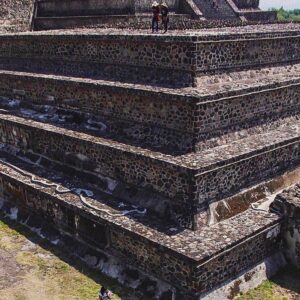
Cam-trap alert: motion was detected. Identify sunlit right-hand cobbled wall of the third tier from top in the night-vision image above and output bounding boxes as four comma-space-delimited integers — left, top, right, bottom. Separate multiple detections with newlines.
197, 142, 300, 207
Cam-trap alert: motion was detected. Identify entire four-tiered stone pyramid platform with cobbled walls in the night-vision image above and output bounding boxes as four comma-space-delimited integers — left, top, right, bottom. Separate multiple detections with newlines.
0, 23, 300, 299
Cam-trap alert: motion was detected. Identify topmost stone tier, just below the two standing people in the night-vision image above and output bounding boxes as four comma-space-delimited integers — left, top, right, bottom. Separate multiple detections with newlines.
0, 24, 300, 87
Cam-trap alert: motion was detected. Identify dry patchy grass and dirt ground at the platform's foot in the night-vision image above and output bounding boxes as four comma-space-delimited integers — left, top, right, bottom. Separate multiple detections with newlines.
0, 219, 300, 300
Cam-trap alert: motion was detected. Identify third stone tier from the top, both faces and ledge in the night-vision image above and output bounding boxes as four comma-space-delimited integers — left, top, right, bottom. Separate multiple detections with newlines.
0, 113, 300, 229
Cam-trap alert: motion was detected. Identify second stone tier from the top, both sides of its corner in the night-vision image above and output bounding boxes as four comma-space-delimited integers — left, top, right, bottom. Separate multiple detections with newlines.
0, 64, 300, 155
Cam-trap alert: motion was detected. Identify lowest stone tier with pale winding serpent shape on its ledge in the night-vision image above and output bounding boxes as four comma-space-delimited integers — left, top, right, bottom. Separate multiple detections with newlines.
0, 152, 281, 299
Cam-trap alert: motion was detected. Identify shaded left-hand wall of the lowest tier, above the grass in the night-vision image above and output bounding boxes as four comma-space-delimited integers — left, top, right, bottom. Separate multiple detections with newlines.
0, 166, 193, 296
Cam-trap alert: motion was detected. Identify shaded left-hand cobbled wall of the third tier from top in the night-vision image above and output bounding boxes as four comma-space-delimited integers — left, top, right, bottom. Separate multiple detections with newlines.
0, 115, 194, 228
